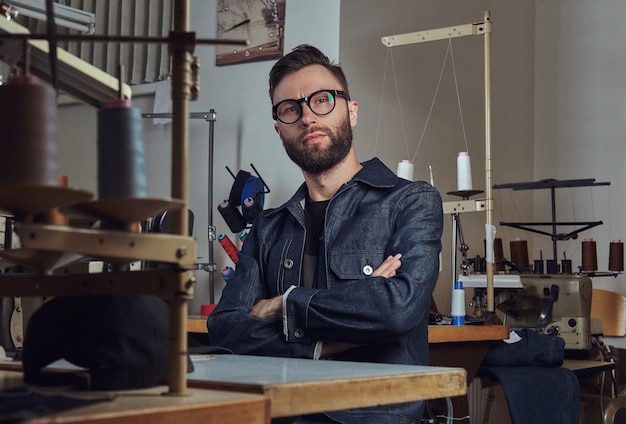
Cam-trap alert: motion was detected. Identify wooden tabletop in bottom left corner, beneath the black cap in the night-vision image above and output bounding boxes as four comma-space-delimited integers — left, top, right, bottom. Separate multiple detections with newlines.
0, 370, 270, 424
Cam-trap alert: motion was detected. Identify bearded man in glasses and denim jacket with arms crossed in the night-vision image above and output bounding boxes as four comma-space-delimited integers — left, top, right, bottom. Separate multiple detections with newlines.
207, 45, 443, 424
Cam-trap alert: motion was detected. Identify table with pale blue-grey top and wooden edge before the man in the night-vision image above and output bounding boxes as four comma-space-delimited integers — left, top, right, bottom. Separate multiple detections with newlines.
187, 355, 467, 418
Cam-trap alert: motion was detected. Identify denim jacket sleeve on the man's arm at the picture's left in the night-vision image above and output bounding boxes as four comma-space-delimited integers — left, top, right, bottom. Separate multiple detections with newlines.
207, 226, 316, 358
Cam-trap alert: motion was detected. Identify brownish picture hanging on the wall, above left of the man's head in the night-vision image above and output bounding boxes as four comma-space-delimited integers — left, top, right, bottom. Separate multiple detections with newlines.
215, 0, 286, 66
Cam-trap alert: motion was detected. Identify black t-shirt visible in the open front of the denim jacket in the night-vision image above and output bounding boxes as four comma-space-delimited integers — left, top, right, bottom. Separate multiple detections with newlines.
301, 197, 328, 288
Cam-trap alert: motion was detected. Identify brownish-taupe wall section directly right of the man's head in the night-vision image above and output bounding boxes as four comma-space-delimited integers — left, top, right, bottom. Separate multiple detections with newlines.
340, 0, 535, 313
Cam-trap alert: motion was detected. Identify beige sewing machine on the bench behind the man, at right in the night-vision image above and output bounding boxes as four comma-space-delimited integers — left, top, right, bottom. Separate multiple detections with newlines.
459, 274, 592, 350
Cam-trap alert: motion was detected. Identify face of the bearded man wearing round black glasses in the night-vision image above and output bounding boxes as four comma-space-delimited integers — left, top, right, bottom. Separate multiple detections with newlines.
274, 65, 357, 175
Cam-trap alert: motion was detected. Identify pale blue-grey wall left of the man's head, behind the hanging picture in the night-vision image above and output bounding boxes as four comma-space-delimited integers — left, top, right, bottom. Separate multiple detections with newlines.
59, 0, 340, 313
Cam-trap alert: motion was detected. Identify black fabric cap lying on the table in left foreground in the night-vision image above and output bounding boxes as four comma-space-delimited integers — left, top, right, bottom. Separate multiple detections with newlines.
23, 296, 169, 390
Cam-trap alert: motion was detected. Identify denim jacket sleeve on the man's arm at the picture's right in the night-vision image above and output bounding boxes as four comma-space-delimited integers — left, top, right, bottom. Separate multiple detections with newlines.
284, 183, 443, 344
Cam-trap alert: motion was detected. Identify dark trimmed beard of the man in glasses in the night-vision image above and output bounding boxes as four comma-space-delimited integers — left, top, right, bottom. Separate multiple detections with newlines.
283, 117, 352, 175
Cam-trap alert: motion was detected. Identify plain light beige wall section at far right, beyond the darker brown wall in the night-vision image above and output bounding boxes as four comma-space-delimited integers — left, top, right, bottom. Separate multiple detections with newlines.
533, 0, 626, 347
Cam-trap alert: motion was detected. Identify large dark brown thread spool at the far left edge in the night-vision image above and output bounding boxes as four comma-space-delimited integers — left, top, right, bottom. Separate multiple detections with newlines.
0, 75, 59, 186
